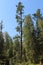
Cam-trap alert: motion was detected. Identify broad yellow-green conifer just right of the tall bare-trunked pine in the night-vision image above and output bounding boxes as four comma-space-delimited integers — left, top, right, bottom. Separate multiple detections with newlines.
23, 15, 34, 61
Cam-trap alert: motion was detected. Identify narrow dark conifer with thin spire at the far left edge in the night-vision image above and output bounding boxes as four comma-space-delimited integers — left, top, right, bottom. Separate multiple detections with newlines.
0, 21, 4, 58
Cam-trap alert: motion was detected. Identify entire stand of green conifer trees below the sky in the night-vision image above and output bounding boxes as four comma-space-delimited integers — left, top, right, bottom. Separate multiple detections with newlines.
0, 2, 43, 65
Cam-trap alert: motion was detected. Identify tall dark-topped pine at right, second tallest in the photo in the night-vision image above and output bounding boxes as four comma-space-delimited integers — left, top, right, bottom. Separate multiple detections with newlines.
33, 9, 42, 62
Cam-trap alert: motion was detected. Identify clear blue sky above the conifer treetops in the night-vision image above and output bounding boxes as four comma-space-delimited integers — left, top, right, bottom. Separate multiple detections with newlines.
0, 0, 43, 37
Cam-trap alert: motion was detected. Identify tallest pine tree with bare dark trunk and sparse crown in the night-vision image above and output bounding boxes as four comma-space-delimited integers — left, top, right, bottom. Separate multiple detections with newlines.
16, 2, 24, 62
